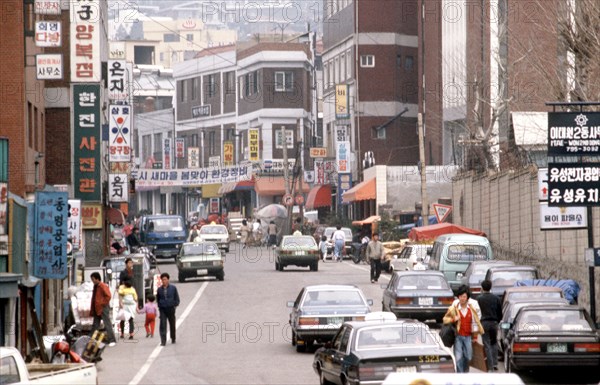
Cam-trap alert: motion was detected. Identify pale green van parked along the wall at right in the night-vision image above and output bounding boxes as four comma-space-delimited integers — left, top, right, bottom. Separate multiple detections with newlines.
429, 234, 494, 291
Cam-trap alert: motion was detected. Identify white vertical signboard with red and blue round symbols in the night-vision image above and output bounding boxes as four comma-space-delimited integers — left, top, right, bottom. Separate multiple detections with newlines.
108, 104, 132, 162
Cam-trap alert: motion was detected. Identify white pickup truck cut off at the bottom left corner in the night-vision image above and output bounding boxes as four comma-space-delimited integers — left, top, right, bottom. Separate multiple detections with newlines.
0, 347, 98, 385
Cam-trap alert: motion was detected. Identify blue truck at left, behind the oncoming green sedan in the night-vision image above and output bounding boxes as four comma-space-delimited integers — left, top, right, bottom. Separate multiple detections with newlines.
139, 214, 187, 258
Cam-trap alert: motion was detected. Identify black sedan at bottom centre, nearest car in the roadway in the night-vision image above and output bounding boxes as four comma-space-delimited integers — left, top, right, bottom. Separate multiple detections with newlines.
313, 313, 455, 385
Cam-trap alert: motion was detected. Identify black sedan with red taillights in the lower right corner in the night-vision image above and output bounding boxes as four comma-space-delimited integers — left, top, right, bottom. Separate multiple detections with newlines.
500, 305, 600, 373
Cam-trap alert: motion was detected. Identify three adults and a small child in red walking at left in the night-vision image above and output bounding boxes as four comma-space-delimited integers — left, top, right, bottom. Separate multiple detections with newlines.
90, 258, 180, 347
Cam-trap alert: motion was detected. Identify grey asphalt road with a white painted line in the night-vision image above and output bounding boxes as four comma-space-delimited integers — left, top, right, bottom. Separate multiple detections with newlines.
98, 244, 597, 385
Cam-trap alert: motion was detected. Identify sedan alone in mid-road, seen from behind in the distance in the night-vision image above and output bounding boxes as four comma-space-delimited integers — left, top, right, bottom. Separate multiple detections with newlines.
275, 235, 321, 271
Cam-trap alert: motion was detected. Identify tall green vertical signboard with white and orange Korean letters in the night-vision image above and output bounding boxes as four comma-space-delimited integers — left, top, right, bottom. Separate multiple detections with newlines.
72, 84, 102, 201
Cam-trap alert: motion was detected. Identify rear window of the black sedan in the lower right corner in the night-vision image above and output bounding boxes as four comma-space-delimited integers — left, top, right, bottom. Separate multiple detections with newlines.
517, 308, 592, 332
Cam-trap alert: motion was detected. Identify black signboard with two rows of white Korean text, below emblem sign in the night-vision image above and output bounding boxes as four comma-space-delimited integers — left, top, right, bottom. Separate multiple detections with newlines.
548, 163, 600, 206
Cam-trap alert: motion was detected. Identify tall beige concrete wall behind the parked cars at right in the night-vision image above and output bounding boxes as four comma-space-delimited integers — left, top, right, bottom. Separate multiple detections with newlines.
452, 168, 600, 318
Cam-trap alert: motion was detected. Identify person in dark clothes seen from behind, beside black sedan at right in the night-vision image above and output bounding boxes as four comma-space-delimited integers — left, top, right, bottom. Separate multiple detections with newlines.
477, 279, 502, 372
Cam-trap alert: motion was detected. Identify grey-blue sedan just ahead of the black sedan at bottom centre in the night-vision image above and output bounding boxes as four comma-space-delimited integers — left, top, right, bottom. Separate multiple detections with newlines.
287, 285, 373, 352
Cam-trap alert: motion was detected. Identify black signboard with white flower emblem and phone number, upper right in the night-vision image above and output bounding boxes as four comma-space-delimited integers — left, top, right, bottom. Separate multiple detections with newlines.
548, 112, 600, 156
